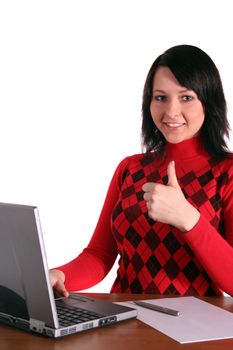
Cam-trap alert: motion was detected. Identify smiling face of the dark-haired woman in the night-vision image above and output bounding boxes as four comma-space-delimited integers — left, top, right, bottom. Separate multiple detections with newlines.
150, 67, 205, 143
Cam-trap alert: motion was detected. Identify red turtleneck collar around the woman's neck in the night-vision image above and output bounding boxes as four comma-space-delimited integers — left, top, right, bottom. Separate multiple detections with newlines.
166, 136, 208, 160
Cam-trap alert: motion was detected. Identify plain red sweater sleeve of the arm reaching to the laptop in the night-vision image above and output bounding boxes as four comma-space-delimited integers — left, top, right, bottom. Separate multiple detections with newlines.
57, 158, 127, 291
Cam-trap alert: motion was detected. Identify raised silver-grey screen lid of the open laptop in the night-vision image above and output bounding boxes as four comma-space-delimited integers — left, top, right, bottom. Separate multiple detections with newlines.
0, 203, 58, 328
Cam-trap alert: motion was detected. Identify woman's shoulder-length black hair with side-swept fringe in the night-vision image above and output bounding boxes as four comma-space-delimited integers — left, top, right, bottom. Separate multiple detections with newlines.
141, 45, 229, 158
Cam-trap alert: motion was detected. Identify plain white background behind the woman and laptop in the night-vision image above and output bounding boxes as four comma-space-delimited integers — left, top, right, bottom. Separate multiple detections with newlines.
0, 0, 233, 292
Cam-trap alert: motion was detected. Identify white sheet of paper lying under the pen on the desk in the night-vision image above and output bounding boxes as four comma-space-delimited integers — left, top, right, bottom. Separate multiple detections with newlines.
117, 297, 233, 344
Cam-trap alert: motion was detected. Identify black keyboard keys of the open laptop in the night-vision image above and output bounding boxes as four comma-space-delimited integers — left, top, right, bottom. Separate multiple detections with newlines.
56, 303, 104, 327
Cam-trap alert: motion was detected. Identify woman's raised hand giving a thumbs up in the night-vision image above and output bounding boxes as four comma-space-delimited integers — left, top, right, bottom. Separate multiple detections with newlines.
142, 161, 200, 232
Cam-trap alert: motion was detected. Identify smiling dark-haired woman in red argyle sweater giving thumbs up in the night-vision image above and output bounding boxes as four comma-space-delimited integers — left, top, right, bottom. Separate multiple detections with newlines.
51, 45, 233, 296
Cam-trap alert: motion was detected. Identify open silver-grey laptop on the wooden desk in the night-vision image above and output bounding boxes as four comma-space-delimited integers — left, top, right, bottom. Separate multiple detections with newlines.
0, 203, 137, 338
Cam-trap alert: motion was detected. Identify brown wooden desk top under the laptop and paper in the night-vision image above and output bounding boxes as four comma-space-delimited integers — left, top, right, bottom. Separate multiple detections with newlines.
0, 294, 233, 350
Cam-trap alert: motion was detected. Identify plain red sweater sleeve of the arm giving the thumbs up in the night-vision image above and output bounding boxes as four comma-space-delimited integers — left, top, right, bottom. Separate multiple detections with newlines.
184, 167, 233, 296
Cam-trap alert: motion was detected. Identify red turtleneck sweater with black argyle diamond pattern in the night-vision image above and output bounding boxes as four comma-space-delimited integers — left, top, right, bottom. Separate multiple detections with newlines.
59, 137, 233, 296
